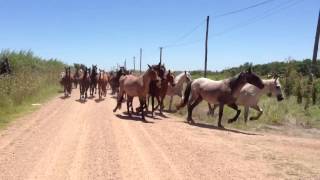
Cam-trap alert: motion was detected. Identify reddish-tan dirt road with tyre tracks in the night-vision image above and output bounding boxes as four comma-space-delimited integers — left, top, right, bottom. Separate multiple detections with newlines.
0, 91, 320, 180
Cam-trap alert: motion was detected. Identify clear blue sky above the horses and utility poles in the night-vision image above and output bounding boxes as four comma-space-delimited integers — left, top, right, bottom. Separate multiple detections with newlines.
0, 0, 320, 70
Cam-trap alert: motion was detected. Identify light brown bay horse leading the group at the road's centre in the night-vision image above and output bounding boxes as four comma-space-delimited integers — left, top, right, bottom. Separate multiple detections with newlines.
113, 65, 158, 120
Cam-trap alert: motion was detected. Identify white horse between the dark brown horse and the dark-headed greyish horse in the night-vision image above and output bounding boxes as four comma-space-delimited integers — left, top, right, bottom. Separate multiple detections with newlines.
166, 71, 192, 111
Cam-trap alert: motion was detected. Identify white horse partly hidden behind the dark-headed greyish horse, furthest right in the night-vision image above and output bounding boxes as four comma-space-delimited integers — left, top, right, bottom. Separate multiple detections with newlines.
210, 76, 284, 123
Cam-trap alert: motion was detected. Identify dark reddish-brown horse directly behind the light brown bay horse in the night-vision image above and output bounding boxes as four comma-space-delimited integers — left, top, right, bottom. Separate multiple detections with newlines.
148, 70, 175, 117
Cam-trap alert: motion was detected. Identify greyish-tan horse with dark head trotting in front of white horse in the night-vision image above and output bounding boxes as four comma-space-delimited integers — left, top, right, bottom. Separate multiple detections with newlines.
177, 67, 264, 128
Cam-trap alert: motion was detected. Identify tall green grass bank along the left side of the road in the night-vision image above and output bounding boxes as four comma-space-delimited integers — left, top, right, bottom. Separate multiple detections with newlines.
0, 50, 64, 128
